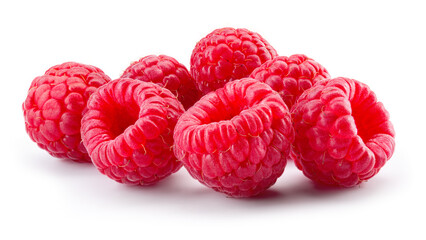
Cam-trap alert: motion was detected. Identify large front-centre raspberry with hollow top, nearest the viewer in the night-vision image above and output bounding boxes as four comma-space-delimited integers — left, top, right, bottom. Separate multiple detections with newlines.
174, 78, 294, 197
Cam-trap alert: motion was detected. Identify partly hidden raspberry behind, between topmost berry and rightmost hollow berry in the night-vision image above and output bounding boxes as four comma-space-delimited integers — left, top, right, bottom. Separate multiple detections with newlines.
250, 54, 330, 109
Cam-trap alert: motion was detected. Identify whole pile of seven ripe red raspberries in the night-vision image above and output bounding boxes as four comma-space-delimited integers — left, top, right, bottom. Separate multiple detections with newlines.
23, 28, 395, 197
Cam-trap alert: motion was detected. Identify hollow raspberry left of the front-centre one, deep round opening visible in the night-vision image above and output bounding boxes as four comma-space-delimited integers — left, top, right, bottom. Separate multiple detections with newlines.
81, 78, 184, 185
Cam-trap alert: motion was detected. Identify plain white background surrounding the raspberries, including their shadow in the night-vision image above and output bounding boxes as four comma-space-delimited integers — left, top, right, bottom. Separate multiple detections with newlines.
0, 0, 426, 239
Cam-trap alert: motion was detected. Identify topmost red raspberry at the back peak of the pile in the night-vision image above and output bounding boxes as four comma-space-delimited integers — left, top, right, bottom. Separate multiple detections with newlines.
191, 28, 277, 94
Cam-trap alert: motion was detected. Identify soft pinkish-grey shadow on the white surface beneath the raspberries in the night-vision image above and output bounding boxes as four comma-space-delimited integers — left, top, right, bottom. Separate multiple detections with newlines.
20, 141, 389, 216
